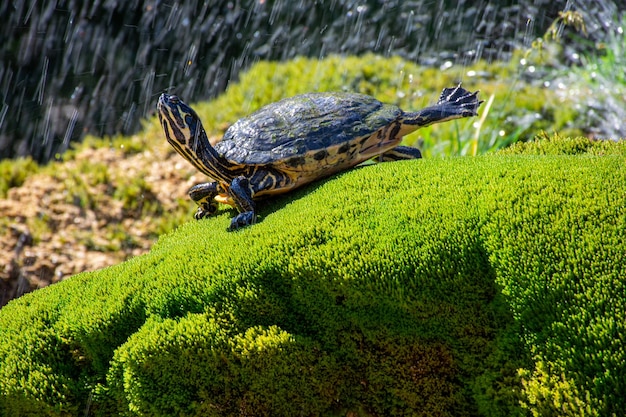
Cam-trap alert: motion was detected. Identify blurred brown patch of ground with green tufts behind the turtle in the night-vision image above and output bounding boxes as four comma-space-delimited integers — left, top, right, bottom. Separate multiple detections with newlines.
0, 136, 205, 306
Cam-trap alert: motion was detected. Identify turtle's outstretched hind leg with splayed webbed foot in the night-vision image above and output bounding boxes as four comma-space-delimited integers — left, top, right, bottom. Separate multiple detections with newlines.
402, 84, 482, 127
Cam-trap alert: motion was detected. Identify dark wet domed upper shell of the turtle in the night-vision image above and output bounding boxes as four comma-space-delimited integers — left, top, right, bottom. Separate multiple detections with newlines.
215, 93, 402, 165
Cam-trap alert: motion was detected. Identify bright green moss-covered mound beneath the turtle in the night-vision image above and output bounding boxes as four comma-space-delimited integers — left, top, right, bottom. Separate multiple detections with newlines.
0, 137, 626, 416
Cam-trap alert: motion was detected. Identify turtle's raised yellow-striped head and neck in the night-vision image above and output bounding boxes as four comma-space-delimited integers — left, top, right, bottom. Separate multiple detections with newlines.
157, 94, 232, 180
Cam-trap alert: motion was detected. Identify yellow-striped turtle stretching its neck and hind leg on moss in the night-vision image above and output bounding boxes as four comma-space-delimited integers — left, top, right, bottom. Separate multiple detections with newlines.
157, 84, 482, 230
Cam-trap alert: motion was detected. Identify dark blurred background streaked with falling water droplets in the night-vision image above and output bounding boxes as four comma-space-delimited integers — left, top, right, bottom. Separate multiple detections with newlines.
0, 0, 623, 162
